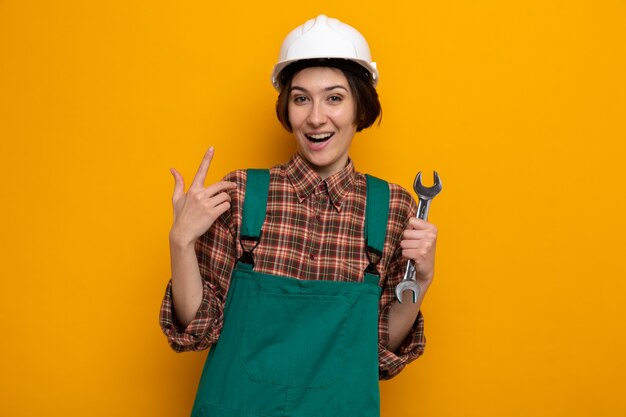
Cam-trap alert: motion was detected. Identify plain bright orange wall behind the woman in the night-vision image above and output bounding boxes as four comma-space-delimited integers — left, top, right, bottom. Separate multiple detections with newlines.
0, 0, 626, 417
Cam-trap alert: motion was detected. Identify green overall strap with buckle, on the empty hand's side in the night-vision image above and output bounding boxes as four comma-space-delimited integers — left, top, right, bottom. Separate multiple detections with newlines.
239, 169, 270, 265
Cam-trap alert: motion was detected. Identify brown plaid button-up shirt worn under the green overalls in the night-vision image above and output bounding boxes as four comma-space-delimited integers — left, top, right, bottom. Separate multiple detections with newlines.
160, 153, 426, 379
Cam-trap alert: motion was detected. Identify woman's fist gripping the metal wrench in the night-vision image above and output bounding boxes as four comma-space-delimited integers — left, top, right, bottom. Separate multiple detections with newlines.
400, 217, 437, 289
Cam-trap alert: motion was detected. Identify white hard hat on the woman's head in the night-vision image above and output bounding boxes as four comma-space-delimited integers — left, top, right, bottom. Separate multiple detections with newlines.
272, 14, 378, 91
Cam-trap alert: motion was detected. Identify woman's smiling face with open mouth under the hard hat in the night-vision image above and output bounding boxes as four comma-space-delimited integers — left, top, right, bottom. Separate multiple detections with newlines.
288, 67, 356, 178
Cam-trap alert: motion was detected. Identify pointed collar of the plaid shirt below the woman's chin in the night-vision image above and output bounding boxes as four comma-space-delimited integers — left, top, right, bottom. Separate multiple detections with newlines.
286, 152, 356, 211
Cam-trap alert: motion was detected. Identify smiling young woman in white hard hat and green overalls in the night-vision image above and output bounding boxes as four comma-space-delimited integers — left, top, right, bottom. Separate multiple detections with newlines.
160, 15, 437, 417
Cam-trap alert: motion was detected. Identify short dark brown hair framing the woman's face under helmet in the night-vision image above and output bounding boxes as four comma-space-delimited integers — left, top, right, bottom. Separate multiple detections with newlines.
276, 63, 383, 132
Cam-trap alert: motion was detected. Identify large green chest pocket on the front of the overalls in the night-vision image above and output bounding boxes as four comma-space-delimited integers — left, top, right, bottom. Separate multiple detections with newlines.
240, 290, 351, 388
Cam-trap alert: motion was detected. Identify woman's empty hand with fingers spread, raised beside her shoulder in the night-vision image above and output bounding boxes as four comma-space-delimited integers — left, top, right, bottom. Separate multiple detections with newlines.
170, 146, 237, 247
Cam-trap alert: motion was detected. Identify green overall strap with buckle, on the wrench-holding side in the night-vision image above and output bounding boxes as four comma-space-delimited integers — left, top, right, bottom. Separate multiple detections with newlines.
365, 174, 389, 279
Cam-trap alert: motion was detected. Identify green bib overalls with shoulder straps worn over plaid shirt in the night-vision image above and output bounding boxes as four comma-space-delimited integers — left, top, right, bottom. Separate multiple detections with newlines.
192, 170, 389, 417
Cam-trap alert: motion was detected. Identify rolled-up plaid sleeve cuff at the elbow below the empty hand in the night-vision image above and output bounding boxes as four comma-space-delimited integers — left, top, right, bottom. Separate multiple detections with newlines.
159, 280, 224, 352
